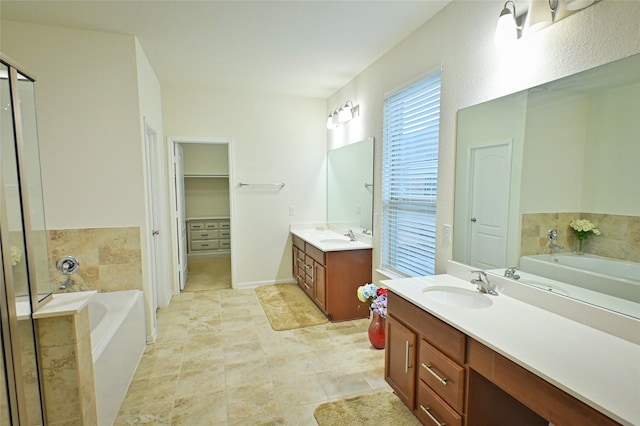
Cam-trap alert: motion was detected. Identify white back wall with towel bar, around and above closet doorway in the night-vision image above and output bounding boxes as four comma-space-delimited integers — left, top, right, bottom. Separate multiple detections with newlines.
162, 86, 326, 287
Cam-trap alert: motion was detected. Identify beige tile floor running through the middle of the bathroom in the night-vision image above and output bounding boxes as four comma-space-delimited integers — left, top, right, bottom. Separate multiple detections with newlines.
115, 258, 390, 426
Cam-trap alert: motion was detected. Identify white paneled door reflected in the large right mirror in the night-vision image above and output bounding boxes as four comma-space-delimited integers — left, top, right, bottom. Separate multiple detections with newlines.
469, 143, 511, 269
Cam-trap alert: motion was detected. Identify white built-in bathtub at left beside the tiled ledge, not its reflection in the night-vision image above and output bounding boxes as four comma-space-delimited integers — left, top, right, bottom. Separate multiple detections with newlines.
88, 290, 146, 426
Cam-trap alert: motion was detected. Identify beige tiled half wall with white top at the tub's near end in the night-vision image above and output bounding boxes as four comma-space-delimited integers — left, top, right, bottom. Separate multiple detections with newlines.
34, 292, 97, 425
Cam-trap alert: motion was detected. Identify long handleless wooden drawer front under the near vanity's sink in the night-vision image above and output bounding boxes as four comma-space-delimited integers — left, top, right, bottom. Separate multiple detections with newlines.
387, 292, 467, 364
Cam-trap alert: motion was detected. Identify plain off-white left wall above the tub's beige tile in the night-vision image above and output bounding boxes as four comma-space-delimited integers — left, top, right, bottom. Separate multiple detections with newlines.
0, 21, 145, 229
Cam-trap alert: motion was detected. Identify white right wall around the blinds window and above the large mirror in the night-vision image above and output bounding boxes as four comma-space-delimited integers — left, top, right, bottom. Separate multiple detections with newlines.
325, 0, 640, 273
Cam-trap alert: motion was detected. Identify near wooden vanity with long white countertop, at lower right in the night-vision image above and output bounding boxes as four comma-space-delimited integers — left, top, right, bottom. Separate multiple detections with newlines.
383, 268, 640, 426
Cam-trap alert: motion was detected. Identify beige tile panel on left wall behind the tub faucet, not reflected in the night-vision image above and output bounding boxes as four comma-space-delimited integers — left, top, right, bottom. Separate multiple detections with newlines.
48, 227, 142, 293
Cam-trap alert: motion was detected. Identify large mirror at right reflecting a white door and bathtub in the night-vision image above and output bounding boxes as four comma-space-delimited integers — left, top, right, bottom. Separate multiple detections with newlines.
453, 55, 640, 318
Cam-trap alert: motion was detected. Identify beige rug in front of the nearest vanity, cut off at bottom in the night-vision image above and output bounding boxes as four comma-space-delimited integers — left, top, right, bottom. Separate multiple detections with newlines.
313, 391, 420, 426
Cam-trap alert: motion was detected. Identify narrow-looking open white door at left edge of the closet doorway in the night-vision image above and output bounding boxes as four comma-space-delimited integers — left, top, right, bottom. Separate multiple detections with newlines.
173, 143, 189, 290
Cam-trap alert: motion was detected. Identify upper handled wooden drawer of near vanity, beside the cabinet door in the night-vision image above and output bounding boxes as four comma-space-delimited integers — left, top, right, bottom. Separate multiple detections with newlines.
419, 340, 464, 413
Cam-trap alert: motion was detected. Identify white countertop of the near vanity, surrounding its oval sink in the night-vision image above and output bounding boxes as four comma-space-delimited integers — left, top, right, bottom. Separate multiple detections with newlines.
382, 275, 640, 425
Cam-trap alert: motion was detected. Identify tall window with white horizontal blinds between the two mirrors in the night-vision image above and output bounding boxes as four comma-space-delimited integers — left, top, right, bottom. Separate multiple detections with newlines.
381, 72, 442, 277
